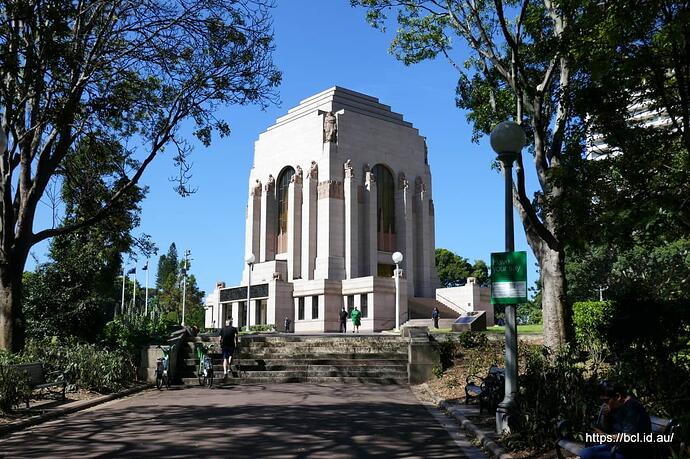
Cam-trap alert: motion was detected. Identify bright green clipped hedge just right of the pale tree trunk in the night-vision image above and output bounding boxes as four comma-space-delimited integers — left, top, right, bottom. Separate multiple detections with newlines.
573, 301, 616, 351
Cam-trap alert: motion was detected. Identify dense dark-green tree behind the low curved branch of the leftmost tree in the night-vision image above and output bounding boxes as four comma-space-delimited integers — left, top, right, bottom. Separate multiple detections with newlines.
23, 137, 146, 340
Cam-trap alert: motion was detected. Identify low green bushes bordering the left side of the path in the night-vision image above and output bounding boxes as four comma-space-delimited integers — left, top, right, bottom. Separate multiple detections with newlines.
22, 339, 136, 393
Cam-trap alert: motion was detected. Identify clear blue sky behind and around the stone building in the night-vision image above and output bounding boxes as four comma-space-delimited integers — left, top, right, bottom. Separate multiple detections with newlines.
27, 0, 536, 293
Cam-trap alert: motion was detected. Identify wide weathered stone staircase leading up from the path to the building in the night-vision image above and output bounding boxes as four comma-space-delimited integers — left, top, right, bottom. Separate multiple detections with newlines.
180, 334, 408, 385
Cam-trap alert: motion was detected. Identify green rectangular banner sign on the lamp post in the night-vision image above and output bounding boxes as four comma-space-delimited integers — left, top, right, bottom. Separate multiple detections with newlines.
491, 252, 527, 304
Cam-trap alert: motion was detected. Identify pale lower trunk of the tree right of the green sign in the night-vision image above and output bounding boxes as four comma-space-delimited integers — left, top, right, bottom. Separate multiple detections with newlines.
538, 243, 571, 351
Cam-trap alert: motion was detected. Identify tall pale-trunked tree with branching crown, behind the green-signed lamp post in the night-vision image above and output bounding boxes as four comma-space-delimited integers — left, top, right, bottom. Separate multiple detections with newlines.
352, 0, 592, 348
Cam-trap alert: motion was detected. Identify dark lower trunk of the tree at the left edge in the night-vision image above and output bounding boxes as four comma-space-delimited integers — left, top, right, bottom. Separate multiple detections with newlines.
0, 263, 25, 352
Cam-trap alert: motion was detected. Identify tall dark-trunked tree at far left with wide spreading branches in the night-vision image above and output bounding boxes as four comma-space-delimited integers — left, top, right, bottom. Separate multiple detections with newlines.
0, 0, 281, 350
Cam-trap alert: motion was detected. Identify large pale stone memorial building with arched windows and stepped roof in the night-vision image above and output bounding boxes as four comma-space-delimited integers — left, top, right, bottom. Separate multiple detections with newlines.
206, 87, 438, 332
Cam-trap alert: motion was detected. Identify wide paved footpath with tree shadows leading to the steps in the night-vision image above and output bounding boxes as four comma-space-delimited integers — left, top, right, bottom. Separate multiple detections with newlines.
0, 384, 485, 459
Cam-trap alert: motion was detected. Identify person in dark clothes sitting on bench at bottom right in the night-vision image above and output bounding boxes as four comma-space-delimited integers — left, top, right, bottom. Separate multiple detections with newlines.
580, 381, 652, 459
